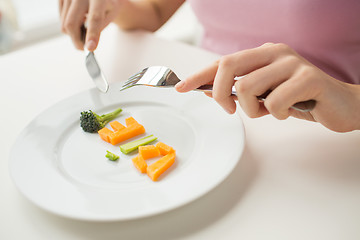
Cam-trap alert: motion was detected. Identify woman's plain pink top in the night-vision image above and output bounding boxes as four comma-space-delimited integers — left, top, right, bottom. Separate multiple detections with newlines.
188, 0, 360, 84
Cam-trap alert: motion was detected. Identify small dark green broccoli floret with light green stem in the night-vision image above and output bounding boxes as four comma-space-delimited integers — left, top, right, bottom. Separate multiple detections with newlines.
80, 108, 122, 133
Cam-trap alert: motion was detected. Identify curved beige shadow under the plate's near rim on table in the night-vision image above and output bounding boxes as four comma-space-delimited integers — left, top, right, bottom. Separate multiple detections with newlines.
18, 143, 258, 240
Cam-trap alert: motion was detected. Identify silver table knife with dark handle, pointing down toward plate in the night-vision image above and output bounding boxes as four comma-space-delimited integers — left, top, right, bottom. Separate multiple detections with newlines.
81, 24, 109, 93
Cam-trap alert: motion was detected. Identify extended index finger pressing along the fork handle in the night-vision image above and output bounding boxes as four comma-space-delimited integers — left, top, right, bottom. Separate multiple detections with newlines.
175, 62, 218, 92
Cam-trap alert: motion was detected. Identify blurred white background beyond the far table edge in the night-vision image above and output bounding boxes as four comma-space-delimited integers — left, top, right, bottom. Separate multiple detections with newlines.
0, 0, 201, 54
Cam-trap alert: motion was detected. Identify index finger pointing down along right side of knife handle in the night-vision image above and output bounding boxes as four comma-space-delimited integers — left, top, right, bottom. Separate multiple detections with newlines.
86, 0, 110, 51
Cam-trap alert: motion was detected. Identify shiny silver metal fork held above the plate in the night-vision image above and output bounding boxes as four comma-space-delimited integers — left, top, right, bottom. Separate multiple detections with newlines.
120, 66, 316, 112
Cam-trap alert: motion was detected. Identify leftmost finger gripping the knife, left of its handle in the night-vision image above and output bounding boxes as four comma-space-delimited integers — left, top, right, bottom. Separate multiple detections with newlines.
65, 1, 88, 50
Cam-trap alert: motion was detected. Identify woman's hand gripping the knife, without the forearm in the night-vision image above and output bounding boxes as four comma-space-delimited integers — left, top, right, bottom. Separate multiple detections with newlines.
59, 0, 125, 51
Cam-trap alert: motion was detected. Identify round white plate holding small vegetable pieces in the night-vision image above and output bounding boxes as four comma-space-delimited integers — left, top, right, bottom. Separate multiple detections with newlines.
10, 83, 244, 221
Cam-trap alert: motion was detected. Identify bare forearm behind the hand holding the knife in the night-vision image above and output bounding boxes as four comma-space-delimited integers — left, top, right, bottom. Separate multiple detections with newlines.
113, 0, 185, 32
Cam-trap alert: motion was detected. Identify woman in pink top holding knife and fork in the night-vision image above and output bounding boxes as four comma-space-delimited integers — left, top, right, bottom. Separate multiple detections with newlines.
60, 0, 360, 132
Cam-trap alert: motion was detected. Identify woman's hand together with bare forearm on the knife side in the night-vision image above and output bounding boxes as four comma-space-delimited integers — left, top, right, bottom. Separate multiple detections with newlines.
59, 0, 185, 51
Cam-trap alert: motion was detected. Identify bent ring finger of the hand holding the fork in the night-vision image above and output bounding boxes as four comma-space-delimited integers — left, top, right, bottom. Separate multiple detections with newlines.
235, 54, 297, 118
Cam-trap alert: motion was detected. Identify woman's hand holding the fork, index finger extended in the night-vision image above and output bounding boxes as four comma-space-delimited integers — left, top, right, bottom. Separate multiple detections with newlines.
176, 43, 360, 132
